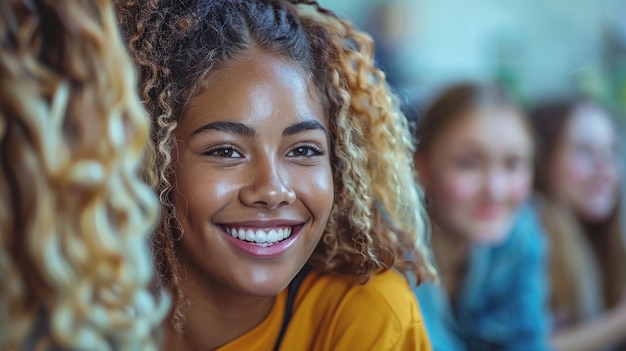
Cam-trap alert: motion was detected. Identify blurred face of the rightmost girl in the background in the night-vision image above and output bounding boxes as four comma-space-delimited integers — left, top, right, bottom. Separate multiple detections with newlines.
549, 105, 621, 221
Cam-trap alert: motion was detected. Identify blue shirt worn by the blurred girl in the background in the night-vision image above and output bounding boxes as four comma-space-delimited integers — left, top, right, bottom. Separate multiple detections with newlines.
414, 205, 550, 351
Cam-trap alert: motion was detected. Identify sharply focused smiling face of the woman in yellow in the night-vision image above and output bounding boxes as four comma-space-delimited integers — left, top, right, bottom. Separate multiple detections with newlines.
172, 53, 334, 296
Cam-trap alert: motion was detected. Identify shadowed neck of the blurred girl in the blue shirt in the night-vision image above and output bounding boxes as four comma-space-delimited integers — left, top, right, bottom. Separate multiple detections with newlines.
432, 224, 471, 298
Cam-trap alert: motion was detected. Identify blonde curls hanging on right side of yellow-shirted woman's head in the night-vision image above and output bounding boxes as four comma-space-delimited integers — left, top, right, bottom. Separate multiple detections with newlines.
296, 1, 435, 283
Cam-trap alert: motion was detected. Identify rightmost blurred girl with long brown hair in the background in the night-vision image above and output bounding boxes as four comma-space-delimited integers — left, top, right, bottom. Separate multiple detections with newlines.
532, 99, 626, 351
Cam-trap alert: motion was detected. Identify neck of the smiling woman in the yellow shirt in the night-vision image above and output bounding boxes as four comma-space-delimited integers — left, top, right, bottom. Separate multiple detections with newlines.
163, 270, 275, 351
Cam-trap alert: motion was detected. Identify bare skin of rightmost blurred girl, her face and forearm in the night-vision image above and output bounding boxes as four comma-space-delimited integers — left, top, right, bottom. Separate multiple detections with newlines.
548, 103, 626, 351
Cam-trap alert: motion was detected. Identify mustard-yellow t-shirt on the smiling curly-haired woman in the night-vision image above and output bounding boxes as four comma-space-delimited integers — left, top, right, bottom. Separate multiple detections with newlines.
218, 270, 431, 351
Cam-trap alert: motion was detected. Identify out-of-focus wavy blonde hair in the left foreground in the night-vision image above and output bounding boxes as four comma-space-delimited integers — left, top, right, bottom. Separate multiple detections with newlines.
0, 0, 167, 350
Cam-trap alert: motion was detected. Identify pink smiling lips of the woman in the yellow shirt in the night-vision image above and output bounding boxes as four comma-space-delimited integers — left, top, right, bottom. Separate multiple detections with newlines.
222, 222, 303, 259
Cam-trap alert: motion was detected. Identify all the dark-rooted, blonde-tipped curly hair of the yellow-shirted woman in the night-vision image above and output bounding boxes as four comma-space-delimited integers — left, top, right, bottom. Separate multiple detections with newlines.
116, 0, 435, 327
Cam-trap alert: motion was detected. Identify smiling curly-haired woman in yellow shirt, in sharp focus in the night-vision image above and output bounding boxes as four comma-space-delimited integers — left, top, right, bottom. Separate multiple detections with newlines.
117, 0, 434, 350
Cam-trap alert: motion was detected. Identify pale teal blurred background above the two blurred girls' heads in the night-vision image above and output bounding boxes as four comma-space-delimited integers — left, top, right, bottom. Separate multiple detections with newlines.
320, 0, 626, 116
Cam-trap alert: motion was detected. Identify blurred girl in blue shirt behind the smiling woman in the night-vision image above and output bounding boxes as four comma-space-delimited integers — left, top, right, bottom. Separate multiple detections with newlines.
415, 84, 548, 351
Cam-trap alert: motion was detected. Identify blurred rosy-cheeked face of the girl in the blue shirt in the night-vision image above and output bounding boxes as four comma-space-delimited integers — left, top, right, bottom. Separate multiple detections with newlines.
417, 108, 533, 243
